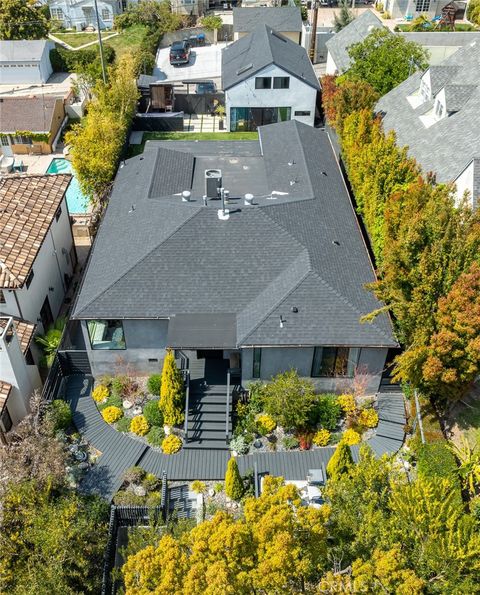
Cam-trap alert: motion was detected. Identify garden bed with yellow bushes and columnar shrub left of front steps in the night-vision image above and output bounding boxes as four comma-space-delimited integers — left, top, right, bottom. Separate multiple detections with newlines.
92, 352, 184, 454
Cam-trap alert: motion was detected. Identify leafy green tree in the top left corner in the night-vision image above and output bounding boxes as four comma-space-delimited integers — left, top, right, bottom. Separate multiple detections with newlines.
0, 0, 49, 40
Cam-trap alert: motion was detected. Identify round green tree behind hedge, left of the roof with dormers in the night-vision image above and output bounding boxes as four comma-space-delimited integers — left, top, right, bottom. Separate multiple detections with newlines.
346, 27, 428, 95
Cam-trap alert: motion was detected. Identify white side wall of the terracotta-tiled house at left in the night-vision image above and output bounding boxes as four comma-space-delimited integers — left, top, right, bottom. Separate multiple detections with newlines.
7, 198, 73, 332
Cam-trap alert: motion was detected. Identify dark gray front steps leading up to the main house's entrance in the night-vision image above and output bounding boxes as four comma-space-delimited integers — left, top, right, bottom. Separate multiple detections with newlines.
184, 381, 232, 450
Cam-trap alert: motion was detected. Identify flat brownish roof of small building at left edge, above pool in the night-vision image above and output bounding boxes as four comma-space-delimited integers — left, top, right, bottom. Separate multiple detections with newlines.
0, 95, 63, 133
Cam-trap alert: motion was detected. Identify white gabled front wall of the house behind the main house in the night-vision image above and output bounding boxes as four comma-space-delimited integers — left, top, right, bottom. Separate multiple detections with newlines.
225, 64, 317, 130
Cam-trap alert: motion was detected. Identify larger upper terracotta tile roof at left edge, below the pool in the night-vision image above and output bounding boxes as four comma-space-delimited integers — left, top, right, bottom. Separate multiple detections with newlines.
0, 174, 71, 288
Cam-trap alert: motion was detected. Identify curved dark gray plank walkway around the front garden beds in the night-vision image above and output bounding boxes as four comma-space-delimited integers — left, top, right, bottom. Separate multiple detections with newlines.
66, 374, 405, 500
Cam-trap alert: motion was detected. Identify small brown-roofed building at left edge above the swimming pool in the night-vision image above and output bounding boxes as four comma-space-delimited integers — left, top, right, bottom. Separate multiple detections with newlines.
0, 95, 67, 156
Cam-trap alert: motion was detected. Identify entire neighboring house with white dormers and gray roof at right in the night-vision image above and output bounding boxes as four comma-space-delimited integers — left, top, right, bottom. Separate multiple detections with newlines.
376, 42, 480, 207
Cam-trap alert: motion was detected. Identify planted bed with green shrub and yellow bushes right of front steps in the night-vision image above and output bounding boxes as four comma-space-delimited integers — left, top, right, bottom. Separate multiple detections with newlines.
230, 370, 378, 454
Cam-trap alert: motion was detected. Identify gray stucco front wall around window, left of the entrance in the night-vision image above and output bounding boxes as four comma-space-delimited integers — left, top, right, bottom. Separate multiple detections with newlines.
82, 319, 168, 376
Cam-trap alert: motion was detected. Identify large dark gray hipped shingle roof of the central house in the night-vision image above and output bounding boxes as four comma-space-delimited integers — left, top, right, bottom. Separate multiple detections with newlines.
74, 121, 395, 346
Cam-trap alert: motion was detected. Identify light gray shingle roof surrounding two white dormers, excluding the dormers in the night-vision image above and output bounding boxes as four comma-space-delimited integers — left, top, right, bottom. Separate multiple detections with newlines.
376, 43, 480, 198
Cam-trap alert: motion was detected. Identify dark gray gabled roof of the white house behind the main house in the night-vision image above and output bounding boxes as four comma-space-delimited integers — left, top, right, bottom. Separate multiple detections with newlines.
222, 24, 320, 90
